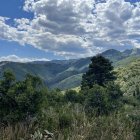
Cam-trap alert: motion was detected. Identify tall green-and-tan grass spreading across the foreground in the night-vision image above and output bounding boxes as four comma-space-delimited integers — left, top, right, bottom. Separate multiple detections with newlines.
0, 104, 135, 140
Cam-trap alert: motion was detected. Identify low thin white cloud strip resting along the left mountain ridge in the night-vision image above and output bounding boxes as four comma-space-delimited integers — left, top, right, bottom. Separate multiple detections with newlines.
0, 55, 49, 63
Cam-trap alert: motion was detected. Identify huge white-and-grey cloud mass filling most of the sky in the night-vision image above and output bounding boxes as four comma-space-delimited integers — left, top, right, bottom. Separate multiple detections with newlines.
0, 0, 140, 58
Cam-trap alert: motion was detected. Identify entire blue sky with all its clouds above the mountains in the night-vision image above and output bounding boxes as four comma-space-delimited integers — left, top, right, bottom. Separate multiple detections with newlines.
0, 0, 140, 62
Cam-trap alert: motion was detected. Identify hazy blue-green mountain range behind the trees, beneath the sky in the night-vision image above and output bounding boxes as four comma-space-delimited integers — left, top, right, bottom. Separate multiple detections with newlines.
0, 49, 140, 89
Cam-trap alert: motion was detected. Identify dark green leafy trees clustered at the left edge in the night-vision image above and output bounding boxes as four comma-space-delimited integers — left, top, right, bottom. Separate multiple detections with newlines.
0, 71, 45, 123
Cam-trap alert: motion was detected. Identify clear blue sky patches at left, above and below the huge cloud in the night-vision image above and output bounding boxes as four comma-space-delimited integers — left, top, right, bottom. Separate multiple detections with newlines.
0, 0, 64, 59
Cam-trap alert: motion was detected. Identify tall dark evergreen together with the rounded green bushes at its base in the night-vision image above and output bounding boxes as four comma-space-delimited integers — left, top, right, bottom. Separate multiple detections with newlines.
81, 55, 123, 116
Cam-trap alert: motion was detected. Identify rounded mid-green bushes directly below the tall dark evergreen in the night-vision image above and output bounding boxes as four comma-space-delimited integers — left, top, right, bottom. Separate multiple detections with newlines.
83, 83, 122, 116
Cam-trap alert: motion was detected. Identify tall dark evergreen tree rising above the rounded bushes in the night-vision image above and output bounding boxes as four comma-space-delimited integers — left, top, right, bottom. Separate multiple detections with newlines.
81, 55, 116, 89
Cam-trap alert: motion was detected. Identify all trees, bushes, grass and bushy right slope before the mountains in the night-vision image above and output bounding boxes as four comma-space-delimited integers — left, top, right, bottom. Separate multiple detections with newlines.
0, 55, 140, 140
